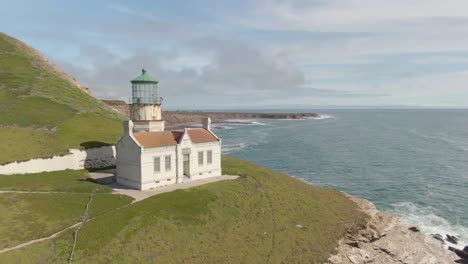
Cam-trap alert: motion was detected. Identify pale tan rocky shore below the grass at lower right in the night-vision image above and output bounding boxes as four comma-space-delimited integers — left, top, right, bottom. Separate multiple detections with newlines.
327, 195, 457, 264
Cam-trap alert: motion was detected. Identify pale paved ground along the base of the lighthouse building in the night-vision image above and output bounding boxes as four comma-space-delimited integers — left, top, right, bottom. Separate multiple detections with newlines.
90, 170, 239, 202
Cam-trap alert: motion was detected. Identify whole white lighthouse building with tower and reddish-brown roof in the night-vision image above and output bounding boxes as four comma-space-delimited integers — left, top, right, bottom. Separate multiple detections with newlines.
116, 70, 221, 190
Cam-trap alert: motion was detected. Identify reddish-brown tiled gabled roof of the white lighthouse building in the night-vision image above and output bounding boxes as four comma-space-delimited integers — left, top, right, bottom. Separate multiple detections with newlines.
133, 128, 219, 148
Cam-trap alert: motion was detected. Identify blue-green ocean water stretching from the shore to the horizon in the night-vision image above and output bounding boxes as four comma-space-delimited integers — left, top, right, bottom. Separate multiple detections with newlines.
215, 110, 468, 244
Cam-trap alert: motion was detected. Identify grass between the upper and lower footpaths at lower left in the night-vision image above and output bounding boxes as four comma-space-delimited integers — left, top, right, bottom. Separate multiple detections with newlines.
0, 193, 132, 249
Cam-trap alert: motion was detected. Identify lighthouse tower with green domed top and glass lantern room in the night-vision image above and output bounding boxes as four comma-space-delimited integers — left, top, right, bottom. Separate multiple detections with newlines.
130, 69, 164, 132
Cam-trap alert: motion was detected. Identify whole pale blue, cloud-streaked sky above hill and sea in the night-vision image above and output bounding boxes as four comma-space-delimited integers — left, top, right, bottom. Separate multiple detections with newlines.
0, 0, 468, 109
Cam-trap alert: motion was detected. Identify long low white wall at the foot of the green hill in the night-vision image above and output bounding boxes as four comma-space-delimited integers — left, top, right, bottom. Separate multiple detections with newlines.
0, 146, 115, 175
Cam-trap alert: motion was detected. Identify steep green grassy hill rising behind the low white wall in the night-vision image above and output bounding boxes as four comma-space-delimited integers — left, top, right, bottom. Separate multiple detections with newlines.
0, 33, 122, 164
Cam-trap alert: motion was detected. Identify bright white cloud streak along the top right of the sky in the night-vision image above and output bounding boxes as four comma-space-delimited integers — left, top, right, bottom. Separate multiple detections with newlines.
239, 0, 468, 32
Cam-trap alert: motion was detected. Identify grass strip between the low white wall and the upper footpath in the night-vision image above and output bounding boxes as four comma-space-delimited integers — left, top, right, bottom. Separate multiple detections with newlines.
0, 170, 111, 193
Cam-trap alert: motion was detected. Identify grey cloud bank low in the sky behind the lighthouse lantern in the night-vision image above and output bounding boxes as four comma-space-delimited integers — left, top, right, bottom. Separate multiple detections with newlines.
62, 41, 370, 107
